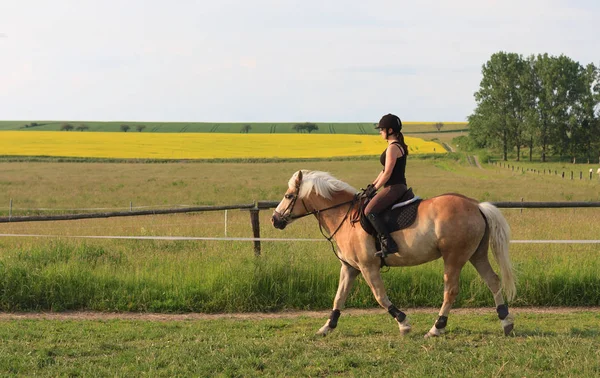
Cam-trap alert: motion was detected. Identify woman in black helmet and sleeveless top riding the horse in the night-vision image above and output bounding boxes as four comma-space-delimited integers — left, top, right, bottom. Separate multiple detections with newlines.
365, 114, 408, 257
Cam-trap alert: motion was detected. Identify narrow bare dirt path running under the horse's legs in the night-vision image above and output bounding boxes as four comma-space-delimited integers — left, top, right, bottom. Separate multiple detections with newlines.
0, 307, 600, 322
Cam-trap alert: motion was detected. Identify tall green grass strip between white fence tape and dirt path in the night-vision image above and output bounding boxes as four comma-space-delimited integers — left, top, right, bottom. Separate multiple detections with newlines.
0, 240, 600, 313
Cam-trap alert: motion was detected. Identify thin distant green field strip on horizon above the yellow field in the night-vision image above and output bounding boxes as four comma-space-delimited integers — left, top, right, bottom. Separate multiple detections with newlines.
0, 121, 468, 135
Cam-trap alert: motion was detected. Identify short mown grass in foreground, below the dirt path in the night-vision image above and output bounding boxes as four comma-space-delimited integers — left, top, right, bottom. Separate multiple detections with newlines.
0, 309, 600, 377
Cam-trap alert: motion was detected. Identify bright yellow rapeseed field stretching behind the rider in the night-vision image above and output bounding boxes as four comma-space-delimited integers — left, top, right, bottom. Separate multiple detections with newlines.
0, 131, 445, 159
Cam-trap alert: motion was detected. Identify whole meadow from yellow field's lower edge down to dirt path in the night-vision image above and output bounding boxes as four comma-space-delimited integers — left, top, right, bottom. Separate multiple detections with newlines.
0, 155, 600, 312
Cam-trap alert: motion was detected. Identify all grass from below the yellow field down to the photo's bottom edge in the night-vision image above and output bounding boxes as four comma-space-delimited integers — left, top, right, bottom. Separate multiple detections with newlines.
0, 154, 600, 377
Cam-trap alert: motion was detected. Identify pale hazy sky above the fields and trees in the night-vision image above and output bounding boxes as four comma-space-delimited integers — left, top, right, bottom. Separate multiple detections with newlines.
0, 0, 600, 122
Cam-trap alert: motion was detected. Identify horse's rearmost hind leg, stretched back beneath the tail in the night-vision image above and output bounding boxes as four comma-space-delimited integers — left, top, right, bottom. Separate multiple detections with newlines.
470, 240, 514, 335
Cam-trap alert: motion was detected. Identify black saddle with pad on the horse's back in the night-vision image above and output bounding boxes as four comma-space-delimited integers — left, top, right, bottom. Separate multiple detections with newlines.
360, 188, 423, 236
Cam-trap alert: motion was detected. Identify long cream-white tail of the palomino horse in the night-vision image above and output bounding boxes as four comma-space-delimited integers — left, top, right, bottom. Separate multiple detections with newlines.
479, 202, 517, 301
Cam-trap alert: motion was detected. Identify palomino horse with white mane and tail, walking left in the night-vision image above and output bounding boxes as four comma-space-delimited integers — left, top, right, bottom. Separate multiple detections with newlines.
272, 170, 516, 337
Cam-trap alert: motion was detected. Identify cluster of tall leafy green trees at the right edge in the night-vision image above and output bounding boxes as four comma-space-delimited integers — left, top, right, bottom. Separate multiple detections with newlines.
468, 52, 600, 161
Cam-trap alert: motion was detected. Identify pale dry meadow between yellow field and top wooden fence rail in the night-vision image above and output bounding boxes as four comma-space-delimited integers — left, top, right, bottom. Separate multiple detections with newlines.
0, 154, 600, 216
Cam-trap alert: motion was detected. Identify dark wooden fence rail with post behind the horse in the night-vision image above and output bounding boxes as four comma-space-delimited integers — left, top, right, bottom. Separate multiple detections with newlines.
0, 201, 600, 256
